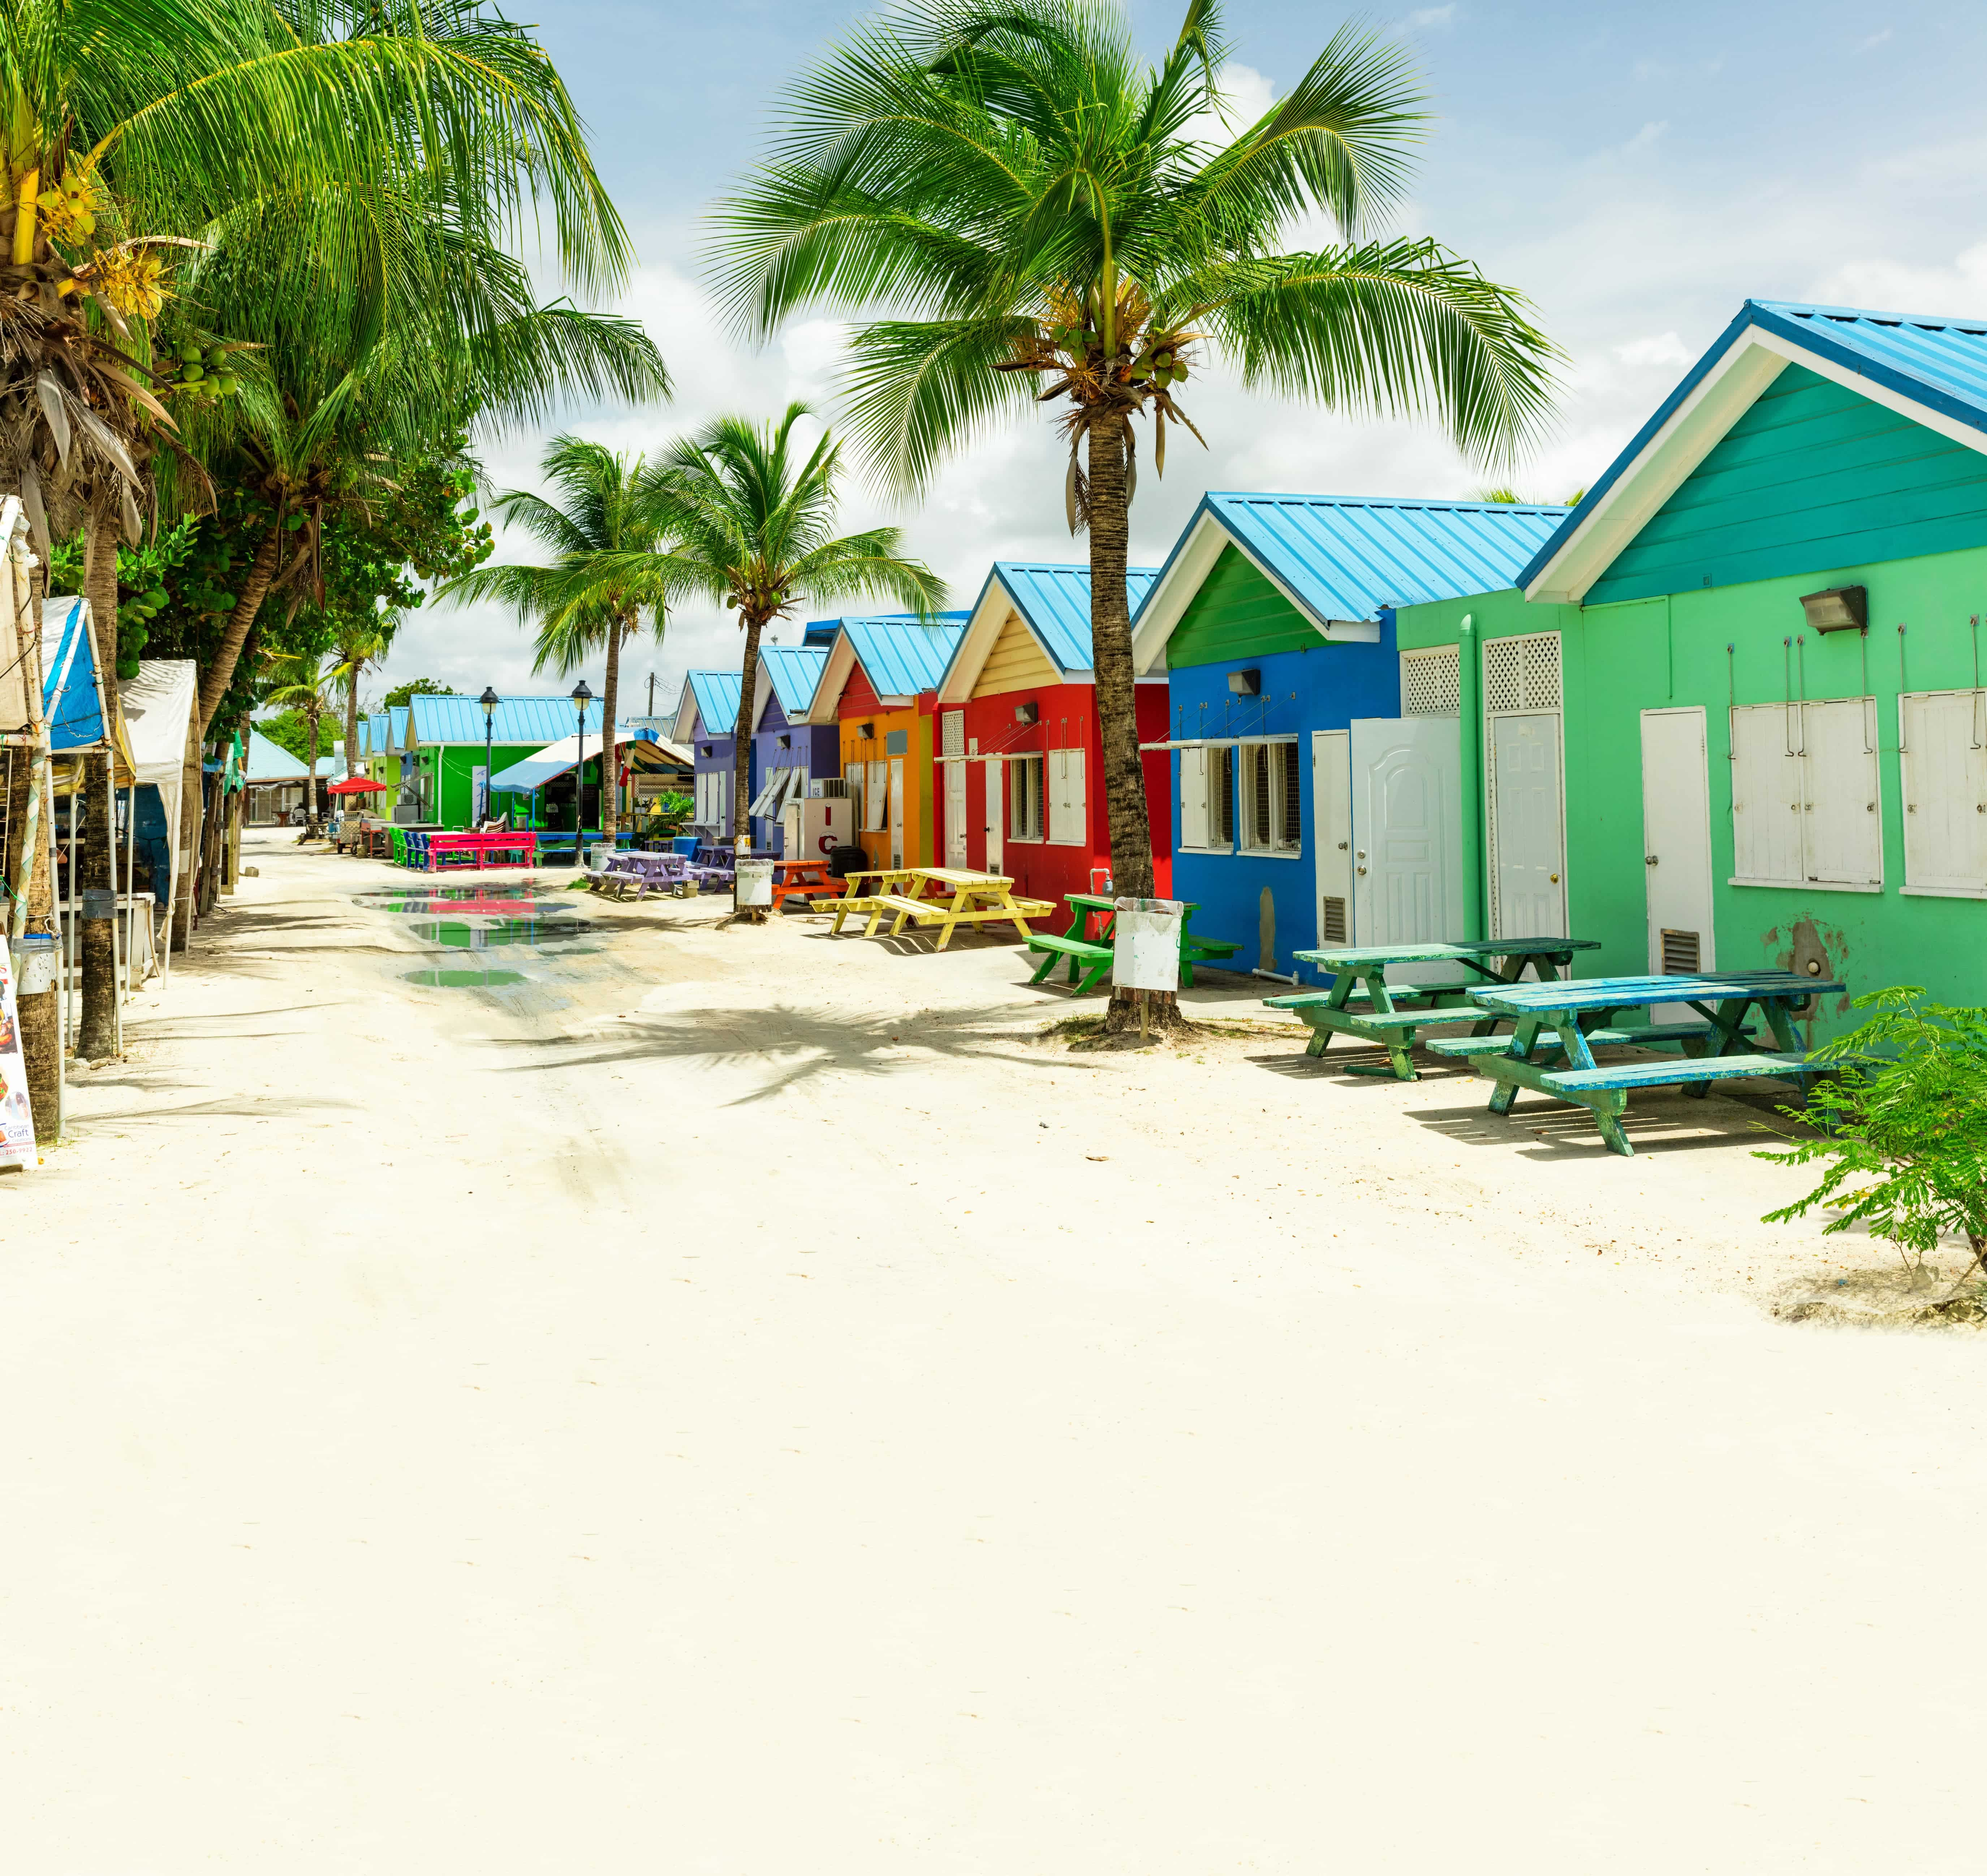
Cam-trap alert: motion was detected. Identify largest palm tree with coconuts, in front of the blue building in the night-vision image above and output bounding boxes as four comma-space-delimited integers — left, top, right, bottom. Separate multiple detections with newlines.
714, 0, 1560, 1021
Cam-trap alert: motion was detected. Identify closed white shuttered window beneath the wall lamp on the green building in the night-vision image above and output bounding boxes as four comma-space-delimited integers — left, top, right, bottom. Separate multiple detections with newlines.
1731, 698, 1884, 890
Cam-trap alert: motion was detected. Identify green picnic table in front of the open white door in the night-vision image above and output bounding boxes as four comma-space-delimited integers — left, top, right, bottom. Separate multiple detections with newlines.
1264, 938, 1600, 1081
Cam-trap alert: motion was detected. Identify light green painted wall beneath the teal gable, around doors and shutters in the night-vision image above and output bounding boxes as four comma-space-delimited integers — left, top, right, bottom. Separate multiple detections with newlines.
1397, 547, 1987, 1036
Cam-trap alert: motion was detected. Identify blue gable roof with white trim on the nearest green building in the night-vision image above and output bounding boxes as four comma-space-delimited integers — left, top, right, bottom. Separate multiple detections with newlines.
1518, 300, 1987, 604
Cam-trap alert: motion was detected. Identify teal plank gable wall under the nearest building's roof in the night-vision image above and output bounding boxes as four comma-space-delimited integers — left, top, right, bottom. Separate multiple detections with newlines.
1588, 366, 1987, 608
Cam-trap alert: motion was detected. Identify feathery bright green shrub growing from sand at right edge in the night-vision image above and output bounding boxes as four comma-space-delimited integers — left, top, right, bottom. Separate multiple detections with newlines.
1759, 984, 1987, 1264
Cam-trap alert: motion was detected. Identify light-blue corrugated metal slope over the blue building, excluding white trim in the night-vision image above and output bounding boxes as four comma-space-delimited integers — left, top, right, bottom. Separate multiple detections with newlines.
1192, 493, 1568, 622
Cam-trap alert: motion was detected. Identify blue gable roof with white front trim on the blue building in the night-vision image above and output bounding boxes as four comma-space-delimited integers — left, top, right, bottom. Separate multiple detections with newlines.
1133, 493, 1568, 672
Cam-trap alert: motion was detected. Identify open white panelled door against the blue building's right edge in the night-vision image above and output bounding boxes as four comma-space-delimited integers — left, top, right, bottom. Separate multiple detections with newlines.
1351, 718, 1465, 984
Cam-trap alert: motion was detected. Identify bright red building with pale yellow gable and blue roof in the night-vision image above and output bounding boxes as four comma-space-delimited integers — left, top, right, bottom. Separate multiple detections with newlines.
932, 560, 1172, 922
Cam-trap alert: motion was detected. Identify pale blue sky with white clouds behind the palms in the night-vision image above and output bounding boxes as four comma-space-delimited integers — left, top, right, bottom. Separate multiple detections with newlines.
370, 0, 1987, 714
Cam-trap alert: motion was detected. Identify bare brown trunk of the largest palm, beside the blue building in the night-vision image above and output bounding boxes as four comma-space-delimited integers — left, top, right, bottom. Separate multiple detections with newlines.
1089, 412, 1180, 1029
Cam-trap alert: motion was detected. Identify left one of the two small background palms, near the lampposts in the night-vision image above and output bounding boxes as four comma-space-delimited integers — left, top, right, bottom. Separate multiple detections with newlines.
439, 435, 688, 841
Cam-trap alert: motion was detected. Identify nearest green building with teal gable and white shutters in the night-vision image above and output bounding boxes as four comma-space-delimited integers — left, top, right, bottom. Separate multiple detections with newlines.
1397, 300, 1987, 1036
